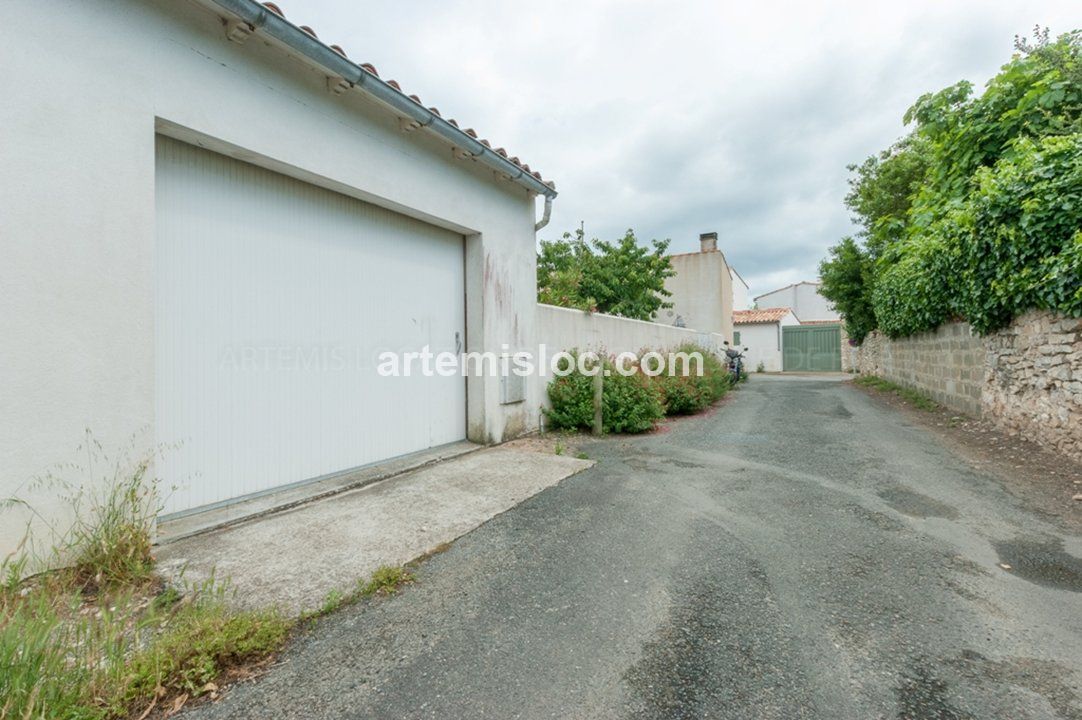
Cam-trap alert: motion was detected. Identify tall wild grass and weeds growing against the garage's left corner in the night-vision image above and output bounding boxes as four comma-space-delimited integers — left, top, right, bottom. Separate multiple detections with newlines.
0, 432, 291, 720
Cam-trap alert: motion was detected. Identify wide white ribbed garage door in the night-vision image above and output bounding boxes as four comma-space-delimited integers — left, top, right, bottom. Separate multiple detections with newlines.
155, 138, 465, 514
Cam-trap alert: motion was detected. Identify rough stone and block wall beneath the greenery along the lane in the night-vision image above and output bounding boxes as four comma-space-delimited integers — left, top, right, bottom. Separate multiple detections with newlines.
857, 311, 1082, 460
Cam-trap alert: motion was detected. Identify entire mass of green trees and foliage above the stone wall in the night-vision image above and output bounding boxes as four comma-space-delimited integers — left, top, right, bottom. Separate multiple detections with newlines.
821, 30, 1082, 337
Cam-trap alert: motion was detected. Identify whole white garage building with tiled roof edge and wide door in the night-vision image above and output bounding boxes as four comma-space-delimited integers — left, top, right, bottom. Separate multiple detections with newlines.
0, 0, 555, 554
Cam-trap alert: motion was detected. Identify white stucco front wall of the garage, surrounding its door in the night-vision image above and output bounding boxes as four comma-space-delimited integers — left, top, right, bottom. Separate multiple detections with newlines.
0, 0, 543, 554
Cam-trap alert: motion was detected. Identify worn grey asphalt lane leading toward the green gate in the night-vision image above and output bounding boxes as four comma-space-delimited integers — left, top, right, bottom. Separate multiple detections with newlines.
190, 377, 1082, 720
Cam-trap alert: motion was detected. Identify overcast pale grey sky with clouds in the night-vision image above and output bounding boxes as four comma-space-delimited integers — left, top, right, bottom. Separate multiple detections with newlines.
280, 0, 1082, 296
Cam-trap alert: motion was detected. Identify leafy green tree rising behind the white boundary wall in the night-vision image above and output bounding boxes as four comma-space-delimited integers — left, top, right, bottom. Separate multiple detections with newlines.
538, 230, 675, 320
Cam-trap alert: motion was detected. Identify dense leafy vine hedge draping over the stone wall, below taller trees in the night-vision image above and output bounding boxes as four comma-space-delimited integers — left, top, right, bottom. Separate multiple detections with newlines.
872, 133, 1082, 337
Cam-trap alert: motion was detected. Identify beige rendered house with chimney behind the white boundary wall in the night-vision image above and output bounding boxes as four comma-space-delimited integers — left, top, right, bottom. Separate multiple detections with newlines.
657, 233, 733, 340
